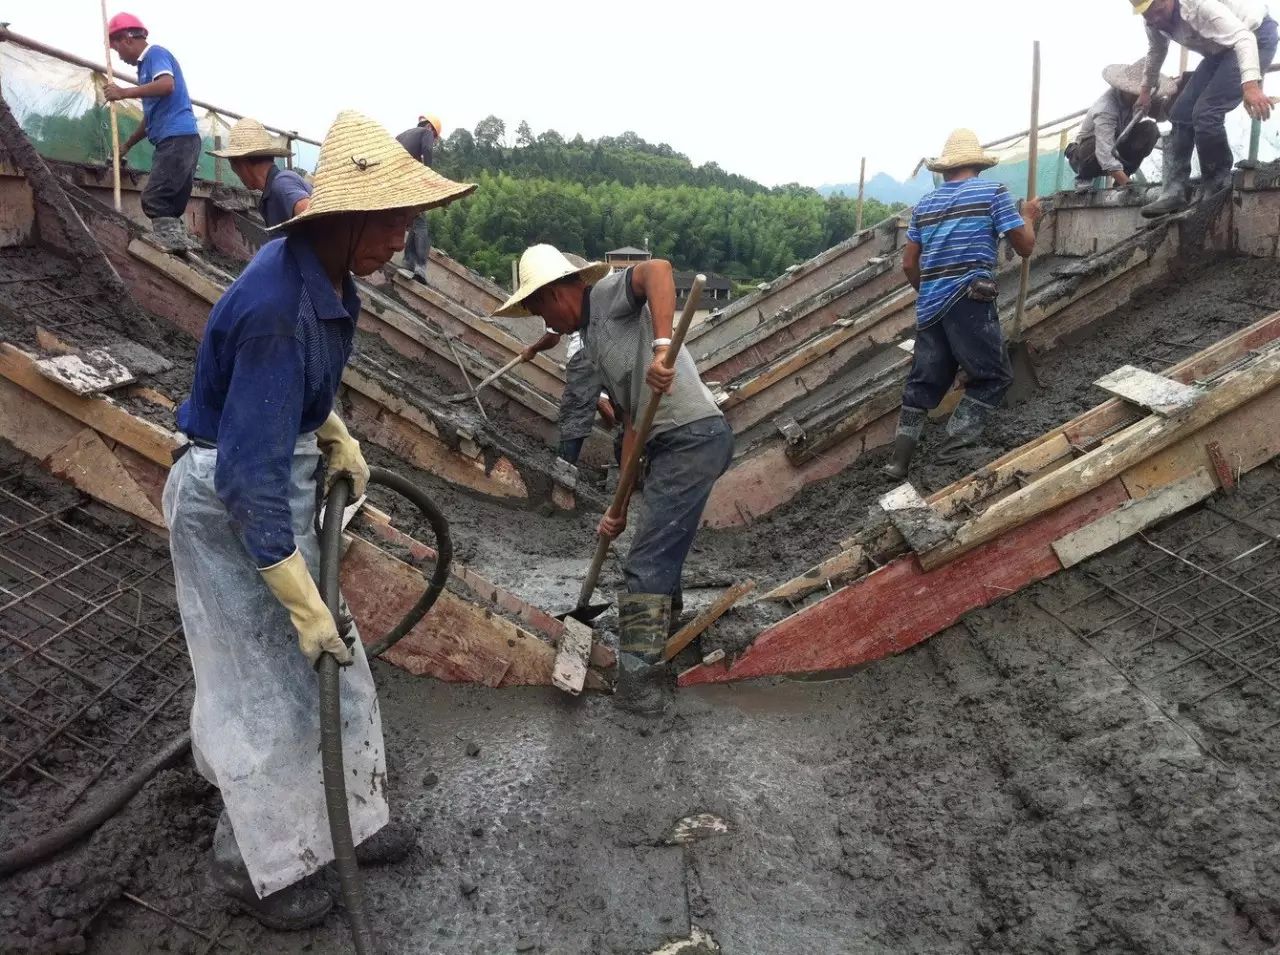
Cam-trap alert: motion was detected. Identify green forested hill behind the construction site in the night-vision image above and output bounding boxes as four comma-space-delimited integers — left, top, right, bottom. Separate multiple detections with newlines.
431, 116, 901, 284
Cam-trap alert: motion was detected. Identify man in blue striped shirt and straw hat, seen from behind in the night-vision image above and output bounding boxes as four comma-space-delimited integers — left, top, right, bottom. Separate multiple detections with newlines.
884, 129, 1041, 479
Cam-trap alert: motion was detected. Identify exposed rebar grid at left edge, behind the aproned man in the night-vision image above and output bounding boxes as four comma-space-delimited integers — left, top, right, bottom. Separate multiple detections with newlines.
0, 471, 191, 812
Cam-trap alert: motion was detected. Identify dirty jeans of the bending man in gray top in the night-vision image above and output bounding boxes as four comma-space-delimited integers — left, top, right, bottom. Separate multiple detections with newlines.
623, 415, 733, 597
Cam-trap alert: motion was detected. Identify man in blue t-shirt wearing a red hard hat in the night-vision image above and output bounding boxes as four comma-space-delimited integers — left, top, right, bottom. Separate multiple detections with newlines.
105, 13, 200, 252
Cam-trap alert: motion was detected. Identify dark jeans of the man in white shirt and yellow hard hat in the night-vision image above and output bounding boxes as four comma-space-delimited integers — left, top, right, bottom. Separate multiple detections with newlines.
1169, 17, 1280, 182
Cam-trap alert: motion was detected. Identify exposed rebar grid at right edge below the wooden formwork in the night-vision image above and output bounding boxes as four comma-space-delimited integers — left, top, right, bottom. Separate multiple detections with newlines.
1059, 478, 1280, 736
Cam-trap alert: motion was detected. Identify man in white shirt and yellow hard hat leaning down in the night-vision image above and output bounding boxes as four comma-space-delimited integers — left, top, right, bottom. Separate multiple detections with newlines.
1129, 0, 1280, 219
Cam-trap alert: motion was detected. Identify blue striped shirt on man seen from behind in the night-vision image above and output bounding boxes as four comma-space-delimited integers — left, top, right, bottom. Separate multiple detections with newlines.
906, 178, 1023, 328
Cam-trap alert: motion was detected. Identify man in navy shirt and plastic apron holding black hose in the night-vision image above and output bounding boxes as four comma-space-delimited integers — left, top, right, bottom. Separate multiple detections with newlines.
164, 111, 475, 929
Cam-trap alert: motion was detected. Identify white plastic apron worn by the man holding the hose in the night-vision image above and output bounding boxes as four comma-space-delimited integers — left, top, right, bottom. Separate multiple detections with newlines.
164, 434, 388, 896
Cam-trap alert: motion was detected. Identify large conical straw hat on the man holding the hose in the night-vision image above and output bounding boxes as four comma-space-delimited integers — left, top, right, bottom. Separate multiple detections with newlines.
271, 110, 475, 230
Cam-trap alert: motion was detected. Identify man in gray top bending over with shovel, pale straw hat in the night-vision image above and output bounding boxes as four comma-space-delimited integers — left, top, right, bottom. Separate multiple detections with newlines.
497, 245, 733, 713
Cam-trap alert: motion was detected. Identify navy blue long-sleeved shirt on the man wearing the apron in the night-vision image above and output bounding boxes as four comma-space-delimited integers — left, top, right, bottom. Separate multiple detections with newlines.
178, 236, 360, 567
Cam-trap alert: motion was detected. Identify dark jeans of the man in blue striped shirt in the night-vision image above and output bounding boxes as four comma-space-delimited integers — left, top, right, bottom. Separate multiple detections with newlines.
902, 298, 1014, 411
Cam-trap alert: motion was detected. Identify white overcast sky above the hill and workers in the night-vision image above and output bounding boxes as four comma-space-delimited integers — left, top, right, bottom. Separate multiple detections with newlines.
0, 0, 1178, 186
